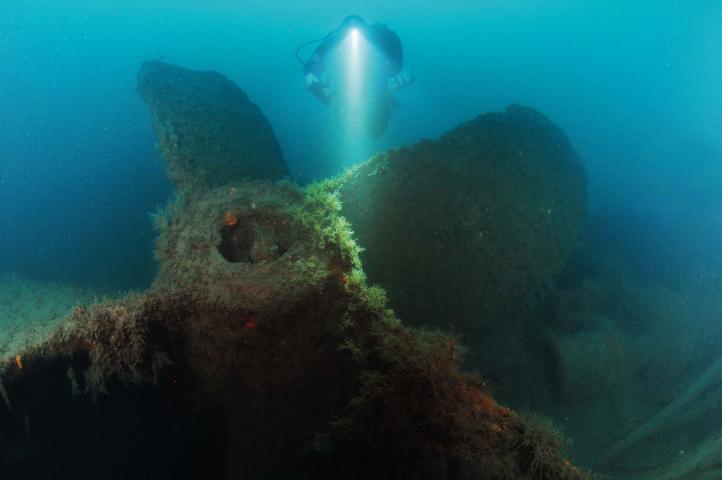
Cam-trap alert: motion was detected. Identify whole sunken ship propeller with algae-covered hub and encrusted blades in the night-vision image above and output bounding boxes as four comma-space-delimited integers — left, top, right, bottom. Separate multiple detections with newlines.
0, 62, 586, 480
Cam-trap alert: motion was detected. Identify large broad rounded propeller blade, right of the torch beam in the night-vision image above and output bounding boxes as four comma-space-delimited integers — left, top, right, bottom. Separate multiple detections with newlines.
340, 105, 586, 332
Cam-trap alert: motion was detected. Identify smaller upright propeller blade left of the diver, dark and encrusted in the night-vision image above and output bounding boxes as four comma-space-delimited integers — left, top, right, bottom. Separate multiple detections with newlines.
138, 61, 288, 189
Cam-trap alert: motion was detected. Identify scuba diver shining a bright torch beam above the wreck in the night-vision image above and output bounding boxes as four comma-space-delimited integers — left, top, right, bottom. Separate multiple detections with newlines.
296, 15, 413, 137
